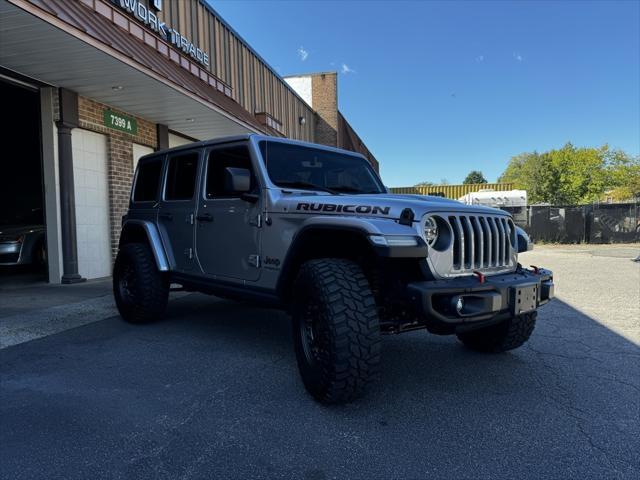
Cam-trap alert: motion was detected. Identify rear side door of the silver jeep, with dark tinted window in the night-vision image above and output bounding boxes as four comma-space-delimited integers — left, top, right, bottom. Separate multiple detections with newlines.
158, 150, 200, 273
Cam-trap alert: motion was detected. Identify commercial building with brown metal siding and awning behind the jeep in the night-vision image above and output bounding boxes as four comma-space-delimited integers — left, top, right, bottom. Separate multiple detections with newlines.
0, 0, 377, 283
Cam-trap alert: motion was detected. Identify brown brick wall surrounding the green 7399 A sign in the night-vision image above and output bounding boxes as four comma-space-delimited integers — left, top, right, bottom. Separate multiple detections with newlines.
78, 97, 157, 258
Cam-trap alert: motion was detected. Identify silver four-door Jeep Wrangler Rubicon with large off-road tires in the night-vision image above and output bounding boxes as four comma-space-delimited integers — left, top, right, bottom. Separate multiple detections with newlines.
113, 135, 553, 403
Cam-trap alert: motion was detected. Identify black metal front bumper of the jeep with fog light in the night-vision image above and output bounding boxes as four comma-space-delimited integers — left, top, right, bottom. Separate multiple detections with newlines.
407, 267, 554, 326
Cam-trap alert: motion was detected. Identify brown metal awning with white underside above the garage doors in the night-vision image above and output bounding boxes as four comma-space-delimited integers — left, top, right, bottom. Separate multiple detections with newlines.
0, 0, 265, 139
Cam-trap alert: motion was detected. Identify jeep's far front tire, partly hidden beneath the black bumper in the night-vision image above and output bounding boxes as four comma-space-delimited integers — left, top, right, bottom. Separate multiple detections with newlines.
456, 312, 538, 353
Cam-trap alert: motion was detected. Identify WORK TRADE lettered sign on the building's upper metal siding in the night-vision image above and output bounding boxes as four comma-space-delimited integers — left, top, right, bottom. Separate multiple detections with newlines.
111, 0, 209, 67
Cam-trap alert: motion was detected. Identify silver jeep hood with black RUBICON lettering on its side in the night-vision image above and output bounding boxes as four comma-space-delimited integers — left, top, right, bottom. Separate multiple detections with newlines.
273, 193, 509, 220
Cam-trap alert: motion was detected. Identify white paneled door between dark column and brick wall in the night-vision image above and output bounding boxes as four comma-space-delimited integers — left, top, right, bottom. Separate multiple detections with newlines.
71, 128, 111, 278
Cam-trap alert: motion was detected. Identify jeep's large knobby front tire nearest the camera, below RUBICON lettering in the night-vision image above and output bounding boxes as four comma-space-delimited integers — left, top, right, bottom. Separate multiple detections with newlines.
292, 259, 380, 404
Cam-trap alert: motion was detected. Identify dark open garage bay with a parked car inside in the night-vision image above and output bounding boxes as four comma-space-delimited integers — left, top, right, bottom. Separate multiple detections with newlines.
0, 81, 47, 287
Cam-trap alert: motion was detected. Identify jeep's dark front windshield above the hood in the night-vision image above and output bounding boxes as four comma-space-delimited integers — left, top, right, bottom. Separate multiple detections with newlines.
260, 141, 385, 194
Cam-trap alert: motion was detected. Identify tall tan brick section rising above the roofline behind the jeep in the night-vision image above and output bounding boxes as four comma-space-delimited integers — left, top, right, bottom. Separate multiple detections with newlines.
311, 72, 338, 147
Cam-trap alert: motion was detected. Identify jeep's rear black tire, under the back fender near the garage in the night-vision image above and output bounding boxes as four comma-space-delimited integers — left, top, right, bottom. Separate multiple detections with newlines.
113, 243, 169, 323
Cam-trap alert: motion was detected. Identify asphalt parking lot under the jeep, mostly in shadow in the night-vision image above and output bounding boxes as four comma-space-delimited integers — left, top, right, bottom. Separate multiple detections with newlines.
0, 246, 640, 480
